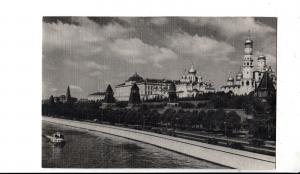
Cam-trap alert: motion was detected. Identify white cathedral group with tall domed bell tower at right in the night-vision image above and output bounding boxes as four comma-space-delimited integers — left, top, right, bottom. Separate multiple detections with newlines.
221, 33, 276, 95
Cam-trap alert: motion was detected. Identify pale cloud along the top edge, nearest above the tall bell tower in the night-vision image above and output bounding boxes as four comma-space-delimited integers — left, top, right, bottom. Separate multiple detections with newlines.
183, 17, 276, 38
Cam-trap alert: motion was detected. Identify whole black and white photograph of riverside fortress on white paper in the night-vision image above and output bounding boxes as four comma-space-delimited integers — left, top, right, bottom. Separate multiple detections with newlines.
40, 16, 278, 170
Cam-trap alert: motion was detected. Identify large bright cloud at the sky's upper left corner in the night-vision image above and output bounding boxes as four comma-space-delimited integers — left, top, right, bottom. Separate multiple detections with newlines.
43, 17, 132, 59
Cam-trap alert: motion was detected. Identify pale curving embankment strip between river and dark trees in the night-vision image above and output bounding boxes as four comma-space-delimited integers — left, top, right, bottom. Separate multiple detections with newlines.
42, 116, 275, 170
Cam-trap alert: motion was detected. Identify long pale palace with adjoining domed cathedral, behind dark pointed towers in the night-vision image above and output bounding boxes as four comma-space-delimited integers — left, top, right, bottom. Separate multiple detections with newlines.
115, 65, 215, 101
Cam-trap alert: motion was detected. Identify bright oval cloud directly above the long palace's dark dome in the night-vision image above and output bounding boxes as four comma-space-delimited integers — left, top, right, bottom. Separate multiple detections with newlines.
109, 38, 178, 67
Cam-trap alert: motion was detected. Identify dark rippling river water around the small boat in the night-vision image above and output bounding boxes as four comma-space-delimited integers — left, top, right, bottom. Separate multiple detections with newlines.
42, 122, 224, 169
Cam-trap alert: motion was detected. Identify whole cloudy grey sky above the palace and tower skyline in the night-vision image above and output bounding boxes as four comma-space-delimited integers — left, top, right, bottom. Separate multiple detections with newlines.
42, 17, 277, 98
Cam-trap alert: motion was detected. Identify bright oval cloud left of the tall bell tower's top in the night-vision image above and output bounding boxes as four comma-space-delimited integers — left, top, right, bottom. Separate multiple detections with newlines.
167, 33, 235, 61
